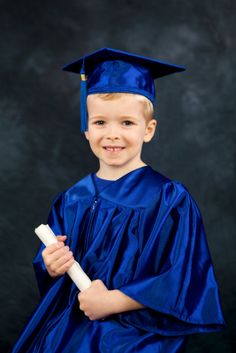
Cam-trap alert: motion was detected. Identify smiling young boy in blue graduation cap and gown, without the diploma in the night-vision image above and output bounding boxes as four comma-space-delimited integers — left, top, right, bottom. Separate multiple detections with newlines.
13, 48, 224, 353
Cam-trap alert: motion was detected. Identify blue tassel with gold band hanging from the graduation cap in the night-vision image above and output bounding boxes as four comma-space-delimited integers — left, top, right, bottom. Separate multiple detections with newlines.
80, 60, 88, 132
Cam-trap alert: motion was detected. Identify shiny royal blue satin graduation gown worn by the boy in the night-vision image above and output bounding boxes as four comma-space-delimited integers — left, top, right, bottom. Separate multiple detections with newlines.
13, 166, 224, 353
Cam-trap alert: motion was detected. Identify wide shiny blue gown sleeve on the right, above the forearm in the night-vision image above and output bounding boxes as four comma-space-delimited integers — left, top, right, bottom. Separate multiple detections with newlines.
119, 182, 225, 336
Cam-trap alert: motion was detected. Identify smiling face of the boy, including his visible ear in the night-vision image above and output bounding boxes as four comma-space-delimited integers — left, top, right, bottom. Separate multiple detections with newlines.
85, 94, 156, 175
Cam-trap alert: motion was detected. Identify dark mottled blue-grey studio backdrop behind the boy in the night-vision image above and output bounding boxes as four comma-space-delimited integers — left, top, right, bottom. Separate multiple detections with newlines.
0, 0, 236, 353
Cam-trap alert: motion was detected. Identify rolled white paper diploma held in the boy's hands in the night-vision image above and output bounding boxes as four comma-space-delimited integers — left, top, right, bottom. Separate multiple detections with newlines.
34, 224, 91, 292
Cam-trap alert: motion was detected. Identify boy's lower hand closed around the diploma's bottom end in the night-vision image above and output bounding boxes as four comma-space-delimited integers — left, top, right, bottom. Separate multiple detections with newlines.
78, 279, 113, 320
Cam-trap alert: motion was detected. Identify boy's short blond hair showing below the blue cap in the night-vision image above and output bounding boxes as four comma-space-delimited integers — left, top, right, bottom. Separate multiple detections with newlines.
91, 92, 154, 121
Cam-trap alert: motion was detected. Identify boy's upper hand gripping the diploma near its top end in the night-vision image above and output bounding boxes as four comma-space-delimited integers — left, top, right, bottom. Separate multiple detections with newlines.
42, 235, 75, 277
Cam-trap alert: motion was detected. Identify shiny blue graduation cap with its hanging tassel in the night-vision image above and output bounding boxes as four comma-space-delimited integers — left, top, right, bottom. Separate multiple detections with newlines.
62, 48, 185, 132
